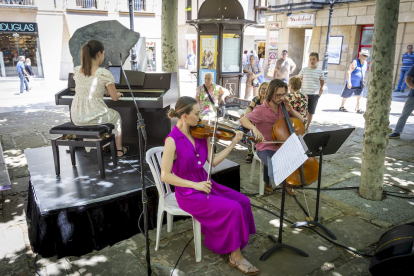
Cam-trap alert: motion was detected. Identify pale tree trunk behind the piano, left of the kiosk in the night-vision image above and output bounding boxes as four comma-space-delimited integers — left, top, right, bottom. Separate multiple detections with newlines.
161, 0, 180, 96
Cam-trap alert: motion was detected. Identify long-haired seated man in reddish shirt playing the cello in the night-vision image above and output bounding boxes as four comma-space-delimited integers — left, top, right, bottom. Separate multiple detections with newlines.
240, 79, 304, 195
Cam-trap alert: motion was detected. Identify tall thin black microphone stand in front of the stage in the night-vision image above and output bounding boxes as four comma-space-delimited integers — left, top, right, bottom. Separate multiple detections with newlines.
119, 53, 152, 275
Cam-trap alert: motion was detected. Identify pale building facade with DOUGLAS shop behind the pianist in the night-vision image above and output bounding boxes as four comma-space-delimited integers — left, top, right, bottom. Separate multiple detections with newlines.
0, 0, 161, 80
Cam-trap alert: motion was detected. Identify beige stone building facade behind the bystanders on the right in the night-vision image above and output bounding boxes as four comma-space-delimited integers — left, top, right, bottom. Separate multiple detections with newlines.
265, 0, 414, 84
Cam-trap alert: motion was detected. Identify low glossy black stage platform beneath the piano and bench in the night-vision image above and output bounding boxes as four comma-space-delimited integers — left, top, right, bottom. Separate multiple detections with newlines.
25, 147, 240, 258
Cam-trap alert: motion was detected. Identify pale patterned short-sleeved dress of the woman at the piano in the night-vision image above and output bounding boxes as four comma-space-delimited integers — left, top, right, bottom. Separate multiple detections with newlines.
70, 66, 121, 135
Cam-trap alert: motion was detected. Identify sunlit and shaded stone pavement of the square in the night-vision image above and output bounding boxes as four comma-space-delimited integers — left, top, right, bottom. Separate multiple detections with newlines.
0, 70, 414, 276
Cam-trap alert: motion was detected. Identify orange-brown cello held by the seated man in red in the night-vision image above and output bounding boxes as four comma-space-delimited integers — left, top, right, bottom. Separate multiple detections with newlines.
272, 102, 319, 188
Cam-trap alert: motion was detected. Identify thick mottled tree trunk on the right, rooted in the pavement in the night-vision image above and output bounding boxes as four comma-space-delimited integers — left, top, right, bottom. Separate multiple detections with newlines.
359, 0, 399, 200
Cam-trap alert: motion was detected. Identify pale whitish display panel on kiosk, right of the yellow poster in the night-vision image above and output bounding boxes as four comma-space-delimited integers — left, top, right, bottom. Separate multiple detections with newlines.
222, 34, 241, 73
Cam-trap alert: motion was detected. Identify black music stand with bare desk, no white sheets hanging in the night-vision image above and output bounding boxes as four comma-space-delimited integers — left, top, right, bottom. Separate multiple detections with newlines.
291, 128, 355, 240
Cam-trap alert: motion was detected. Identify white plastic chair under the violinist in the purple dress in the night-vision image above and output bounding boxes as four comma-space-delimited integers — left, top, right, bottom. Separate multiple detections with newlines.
145, 147, 201, 262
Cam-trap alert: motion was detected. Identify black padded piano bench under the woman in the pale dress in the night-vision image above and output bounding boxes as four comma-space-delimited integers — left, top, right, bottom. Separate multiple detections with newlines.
49, 122, 118, 179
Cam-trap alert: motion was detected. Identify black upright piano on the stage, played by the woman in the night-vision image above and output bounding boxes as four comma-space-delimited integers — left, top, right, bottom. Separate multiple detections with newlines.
55, 70, 178, 148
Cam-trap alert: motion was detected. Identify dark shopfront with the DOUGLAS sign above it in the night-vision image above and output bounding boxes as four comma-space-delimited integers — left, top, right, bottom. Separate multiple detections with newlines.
0, 22, 43, 77
